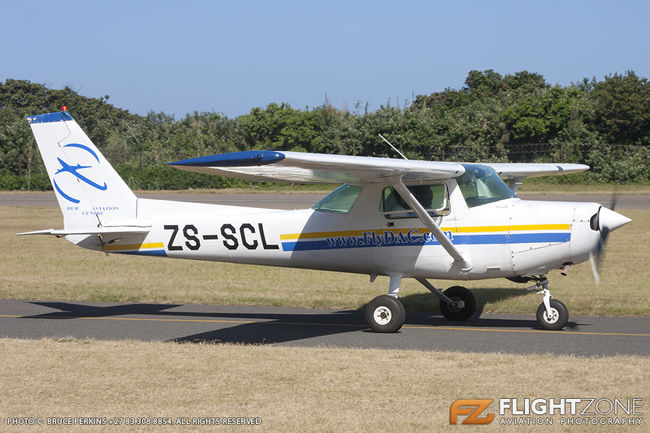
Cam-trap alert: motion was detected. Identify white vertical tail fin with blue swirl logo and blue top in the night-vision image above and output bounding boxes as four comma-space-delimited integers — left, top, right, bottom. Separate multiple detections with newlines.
27, 111, 137, 230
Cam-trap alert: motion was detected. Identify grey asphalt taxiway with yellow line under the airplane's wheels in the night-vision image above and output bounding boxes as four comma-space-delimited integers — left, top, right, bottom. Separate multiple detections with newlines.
0, 300, 650, 356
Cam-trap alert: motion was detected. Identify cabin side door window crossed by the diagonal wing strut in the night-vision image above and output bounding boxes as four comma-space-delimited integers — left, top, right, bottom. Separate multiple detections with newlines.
379, 183, 450, 218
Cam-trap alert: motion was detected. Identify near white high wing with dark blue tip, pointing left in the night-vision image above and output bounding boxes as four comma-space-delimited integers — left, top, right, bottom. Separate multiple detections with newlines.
169, 150, 465, 183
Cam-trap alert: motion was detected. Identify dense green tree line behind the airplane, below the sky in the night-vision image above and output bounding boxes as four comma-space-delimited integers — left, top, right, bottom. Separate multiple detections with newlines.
0, 70, 650, 189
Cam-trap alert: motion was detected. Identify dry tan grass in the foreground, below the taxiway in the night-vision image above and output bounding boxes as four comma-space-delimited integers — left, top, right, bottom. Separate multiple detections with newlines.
0, 338, 650, 432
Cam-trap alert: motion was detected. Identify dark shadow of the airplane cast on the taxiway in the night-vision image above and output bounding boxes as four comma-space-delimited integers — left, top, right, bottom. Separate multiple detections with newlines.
25, 295, 577, 344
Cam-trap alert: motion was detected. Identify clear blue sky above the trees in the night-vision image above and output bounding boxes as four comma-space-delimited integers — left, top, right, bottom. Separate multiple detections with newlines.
0, 0, 650, 118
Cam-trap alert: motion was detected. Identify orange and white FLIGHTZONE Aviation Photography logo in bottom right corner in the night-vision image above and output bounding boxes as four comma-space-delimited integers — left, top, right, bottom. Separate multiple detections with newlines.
449, 398, 643, 426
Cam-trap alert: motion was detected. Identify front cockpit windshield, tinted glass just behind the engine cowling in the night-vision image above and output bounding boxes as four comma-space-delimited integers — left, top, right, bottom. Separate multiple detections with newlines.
456, 164, 515, 207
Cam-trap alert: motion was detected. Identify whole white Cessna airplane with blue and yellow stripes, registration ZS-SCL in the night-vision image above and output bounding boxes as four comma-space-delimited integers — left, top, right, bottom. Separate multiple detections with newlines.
20, 111, 630, 332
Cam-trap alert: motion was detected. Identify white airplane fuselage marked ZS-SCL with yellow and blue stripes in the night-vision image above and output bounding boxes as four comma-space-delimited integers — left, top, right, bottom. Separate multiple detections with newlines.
68, 179, 599, 279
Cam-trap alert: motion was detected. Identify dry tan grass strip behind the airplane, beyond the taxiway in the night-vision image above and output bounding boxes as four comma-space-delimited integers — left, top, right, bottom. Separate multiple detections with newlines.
0, 206, 650, 316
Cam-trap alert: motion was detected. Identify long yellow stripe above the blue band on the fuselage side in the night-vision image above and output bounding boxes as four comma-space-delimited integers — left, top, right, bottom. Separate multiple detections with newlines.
280, 224, 571, 241
